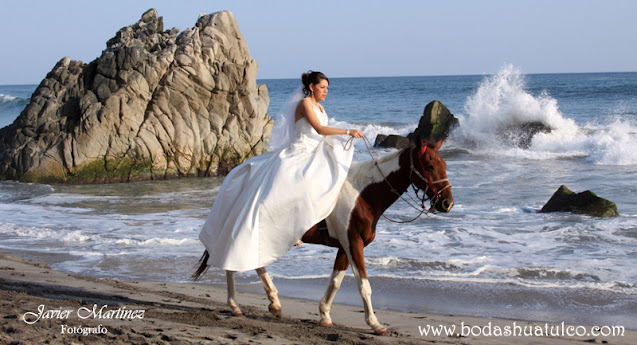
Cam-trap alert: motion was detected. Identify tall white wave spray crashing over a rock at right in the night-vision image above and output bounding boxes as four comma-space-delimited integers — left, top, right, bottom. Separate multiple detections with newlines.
453, 66, 637, 165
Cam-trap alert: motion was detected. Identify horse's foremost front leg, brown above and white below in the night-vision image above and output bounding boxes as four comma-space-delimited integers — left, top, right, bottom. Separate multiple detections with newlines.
348, 235, 389, 335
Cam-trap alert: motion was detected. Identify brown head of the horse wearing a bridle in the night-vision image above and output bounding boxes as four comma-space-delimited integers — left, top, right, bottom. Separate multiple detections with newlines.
411, 138, 453, 212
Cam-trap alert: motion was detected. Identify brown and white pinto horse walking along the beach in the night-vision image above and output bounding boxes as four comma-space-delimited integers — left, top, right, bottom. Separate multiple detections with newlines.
193, 139, 454, 335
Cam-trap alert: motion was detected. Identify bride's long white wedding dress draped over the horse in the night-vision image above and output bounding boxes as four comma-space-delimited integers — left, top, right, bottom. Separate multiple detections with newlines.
199, 102, 354, 272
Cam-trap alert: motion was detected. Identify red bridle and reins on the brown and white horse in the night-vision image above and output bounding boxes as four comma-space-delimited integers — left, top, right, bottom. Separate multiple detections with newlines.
352, 136, 451, 223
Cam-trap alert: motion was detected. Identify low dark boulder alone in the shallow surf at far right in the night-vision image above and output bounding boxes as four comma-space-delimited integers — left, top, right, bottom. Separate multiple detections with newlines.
541, 186, 619, 217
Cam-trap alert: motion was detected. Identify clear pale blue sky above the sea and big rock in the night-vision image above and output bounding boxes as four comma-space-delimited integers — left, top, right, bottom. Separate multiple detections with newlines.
0, 0, 637, 85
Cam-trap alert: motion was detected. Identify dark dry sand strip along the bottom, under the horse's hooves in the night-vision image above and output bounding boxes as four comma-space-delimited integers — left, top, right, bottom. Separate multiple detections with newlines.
0, 252, 637, 344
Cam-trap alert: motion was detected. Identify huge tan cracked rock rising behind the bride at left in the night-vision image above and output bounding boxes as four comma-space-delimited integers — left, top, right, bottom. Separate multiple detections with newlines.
0, 9, 272, 182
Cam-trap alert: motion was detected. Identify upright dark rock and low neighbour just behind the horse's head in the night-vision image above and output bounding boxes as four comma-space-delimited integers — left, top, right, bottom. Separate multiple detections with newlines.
374, 100, 458, 149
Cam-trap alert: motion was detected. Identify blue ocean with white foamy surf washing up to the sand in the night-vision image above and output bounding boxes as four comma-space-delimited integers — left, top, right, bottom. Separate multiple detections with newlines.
0, 66, 637, 329
